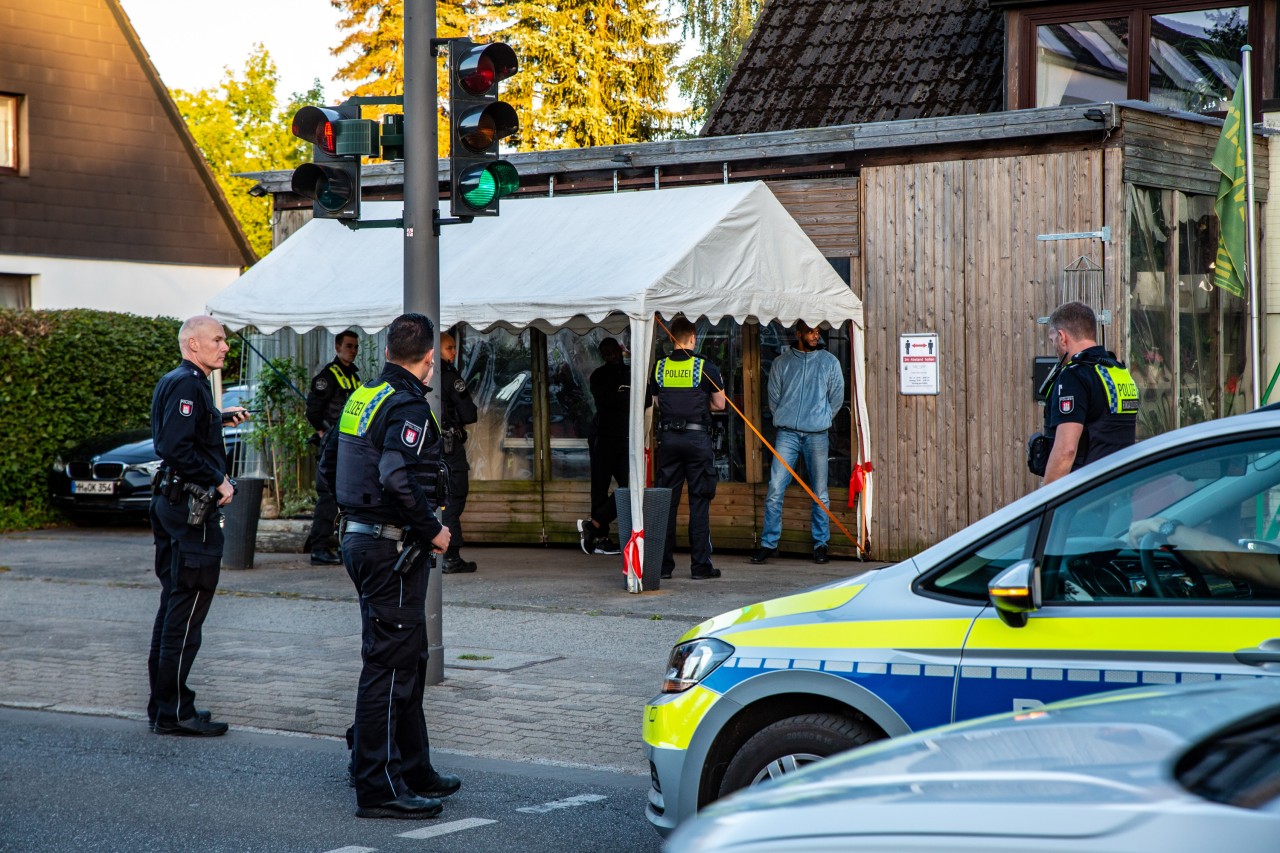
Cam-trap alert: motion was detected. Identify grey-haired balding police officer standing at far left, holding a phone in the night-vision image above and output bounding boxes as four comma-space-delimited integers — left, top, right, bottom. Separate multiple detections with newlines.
147, 315, 248, 738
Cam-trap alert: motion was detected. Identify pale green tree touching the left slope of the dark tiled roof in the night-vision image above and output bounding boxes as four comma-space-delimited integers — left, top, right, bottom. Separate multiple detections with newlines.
675, 0, 764, 126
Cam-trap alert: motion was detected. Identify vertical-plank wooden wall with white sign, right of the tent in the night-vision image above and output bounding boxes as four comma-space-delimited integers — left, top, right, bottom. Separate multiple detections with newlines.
861, 150, 1123, 560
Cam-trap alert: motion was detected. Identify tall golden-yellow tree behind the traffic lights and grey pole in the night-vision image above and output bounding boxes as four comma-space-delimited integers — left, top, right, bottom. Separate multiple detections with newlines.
330, 0, 678, 155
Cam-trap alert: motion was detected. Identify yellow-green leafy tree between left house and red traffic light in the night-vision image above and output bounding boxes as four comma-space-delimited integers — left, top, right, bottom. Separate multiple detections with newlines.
172, 45, 324, 257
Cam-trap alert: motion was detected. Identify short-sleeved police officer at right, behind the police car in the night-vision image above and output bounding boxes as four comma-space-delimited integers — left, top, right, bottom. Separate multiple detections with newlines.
1044, 302, 1138, 484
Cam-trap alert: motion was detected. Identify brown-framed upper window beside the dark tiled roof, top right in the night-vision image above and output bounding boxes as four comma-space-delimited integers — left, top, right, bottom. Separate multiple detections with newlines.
1010, 3, 1249, 113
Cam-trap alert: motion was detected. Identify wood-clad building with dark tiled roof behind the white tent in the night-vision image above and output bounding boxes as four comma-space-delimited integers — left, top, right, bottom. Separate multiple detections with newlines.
244, 0, 1275, 558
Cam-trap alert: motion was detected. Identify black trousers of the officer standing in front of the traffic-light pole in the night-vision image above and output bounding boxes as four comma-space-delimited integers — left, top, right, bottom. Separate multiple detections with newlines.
342, 533, 438, 808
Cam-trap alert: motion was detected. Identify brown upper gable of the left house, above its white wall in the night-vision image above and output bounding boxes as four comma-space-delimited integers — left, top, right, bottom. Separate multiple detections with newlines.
0, 0, 256, 268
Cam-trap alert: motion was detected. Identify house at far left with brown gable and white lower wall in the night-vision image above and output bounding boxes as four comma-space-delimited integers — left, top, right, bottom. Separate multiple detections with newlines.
0, 0, 256, 316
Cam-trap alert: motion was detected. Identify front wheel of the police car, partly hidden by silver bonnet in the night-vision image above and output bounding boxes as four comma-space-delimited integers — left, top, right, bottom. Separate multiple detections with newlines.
719, 713, 879, 797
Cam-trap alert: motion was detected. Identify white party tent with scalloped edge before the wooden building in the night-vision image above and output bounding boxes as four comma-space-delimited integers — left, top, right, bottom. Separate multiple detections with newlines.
209, 182, 870, 581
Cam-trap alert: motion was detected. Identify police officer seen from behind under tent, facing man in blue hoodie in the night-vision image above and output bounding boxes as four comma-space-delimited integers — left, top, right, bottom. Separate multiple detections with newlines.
648, 316, 724, 580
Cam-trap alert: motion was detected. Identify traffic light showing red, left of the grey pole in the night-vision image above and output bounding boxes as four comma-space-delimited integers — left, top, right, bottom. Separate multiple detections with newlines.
292, 101, 379, 220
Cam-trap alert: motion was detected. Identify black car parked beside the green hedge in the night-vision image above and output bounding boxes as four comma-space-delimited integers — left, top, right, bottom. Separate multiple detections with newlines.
49, 386, 247, 524
